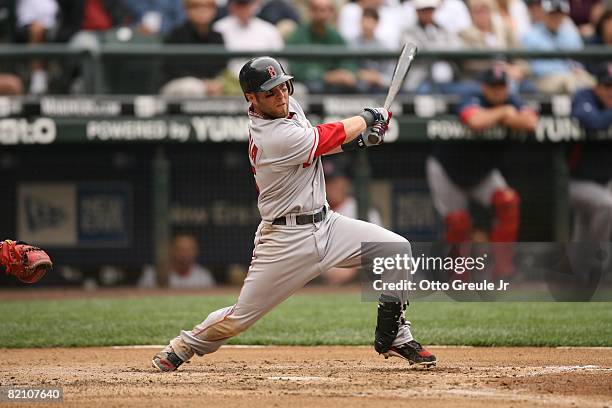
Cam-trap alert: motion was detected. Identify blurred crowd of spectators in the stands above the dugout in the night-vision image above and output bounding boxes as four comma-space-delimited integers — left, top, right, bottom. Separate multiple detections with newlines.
0, 0, 612, 96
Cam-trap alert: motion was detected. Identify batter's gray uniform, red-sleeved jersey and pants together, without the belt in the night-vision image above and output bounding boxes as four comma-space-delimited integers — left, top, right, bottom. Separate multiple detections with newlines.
177, 98, 412, 355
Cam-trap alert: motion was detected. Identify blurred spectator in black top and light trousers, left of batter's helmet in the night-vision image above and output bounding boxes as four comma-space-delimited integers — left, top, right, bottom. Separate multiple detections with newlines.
161, 0, 225, 97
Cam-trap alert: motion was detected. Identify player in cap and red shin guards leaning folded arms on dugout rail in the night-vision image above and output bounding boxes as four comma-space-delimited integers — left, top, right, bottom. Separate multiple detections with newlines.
426, 66, 538, 277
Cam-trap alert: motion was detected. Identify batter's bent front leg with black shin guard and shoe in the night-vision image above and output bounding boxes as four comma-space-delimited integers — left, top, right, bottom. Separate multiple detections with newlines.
322, 213, 436, 366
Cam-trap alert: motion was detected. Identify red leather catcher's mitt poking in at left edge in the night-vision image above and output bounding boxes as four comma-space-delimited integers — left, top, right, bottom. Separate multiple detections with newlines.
0, 239, 53, 283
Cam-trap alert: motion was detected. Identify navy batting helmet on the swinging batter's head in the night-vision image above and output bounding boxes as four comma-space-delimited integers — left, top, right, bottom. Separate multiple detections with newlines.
238, 57, 293, 101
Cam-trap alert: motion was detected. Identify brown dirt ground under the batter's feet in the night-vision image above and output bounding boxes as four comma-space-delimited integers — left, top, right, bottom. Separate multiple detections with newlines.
0, 347, 612, 408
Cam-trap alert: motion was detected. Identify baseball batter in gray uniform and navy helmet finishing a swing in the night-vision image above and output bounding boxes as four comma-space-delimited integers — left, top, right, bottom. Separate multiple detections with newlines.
153, 57, 436, 371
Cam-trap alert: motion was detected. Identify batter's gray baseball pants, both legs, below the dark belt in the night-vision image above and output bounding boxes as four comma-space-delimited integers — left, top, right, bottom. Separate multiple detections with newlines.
179, 211, 412, 355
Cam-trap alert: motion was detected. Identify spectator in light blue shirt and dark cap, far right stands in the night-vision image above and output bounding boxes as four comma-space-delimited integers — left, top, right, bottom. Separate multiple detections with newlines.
523, 0, 594, 94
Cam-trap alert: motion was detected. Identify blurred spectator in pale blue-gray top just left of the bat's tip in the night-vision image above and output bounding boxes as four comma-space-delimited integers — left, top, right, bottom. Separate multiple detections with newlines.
349, 9, 395, 93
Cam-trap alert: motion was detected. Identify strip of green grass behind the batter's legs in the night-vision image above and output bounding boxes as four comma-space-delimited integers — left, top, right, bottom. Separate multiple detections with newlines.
0, 294, 612, 347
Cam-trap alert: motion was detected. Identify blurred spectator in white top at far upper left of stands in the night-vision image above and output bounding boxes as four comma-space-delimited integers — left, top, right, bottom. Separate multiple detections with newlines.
15, 0, 58, 94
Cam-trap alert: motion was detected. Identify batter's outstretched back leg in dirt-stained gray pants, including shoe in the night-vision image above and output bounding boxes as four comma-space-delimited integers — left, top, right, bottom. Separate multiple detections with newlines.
153, 225, 321, 371
